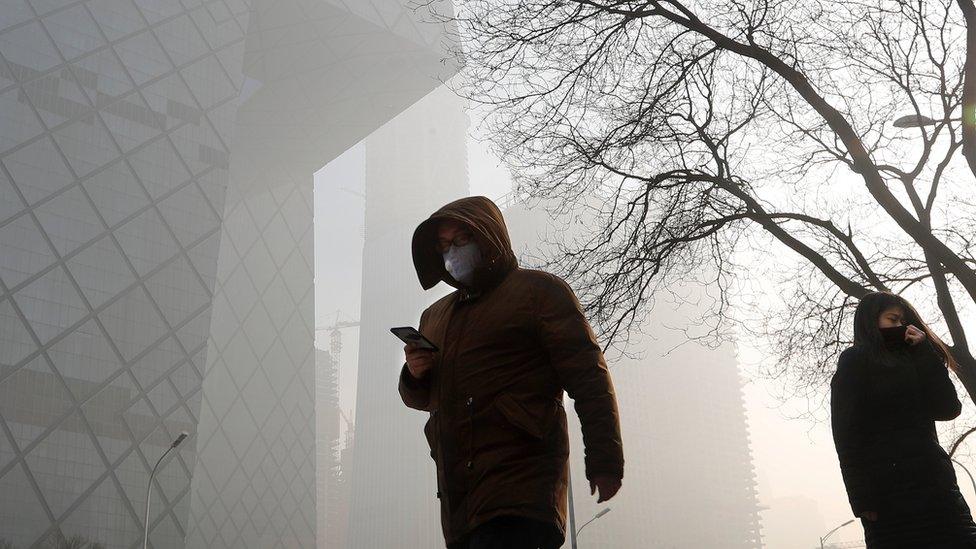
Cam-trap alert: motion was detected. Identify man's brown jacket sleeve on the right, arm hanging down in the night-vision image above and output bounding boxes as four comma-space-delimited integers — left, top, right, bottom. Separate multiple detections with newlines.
536, 275, 624, 479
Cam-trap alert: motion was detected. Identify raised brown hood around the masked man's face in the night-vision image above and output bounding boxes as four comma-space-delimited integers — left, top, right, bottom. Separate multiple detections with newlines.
411, 196, 518, 291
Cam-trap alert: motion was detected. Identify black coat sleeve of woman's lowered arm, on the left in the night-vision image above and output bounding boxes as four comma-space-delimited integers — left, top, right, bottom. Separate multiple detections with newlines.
830, 349, 878, 517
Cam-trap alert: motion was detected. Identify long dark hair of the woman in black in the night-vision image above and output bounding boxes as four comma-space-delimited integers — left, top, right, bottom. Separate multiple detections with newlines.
854, 292, 957, 370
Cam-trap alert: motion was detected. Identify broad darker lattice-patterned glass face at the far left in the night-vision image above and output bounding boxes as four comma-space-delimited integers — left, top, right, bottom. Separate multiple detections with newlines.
0, 0, 248, 547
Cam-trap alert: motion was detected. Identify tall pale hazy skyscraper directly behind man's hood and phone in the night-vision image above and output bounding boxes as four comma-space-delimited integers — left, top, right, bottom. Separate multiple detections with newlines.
349, 83, 468, 549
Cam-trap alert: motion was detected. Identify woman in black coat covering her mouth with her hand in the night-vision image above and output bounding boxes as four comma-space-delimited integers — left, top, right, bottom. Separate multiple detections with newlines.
830, 292, 976, 549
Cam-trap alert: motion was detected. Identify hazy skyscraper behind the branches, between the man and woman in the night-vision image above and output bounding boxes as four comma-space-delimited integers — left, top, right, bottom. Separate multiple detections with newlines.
504, 199, 762, 549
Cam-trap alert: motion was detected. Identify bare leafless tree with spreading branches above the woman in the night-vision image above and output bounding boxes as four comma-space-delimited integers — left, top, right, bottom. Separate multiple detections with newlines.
426, 0, 976, 397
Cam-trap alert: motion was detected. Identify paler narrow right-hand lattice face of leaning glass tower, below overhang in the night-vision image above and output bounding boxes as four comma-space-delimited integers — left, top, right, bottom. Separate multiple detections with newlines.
187, 147, 315, 547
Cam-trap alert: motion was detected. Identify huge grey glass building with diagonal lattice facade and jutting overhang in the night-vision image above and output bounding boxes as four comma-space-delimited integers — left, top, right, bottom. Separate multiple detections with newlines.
0, 0, 453, 548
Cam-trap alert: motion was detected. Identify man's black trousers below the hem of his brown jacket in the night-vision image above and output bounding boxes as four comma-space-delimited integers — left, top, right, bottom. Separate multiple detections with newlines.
447, 517, 563, 549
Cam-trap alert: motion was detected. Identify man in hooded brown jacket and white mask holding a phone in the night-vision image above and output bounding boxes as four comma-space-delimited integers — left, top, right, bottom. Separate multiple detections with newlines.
400, 196, 624, 549
